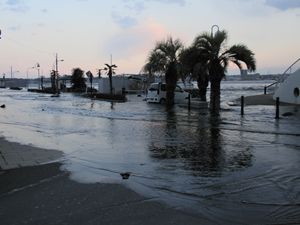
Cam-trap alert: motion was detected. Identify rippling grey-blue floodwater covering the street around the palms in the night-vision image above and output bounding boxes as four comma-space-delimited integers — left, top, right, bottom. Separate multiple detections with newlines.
0, 80, 300, 224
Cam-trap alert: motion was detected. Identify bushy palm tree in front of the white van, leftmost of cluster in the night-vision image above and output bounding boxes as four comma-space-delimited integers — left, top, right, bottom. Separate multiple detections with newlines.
144, 37, 183, 106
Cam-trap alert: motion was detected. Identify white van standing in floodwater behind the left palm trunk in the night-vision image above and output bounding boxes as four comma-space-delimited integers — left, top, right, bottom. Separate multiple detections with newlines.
146, 83, 189, 104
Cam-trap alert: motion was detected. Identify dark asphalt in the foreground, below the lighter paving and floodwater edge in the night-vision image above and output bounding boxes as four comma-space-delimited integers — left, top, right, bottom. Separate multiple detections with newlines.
0, 163, 213, 225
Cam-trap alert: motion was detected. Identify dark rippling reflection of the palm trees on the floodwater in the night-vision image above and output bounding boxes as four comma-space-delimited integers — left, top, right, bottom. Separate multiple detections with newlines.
148, 110, 252, 176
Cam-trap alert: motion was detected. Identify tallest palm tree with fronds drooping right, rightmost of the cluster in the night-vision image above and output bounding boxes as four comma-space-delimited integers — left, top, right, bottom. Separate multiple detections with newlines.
193, 31, 256, 114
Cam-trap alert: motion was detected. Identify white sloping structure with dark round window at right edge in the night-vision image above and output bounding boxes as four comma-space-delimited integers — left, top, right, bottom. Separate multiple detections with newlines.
273, 58, 300, 105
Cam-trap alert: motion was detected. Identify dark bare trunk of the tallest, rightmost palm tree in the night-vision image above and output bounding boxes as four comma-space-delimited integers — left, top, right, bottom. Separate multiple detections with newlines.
209, 79, 221, 115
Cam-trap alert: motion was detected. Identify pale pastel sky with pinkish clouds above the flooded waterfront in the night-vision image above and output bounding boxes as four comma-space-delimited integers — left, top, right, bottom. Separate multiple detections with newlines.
0, 0, 300, 78
